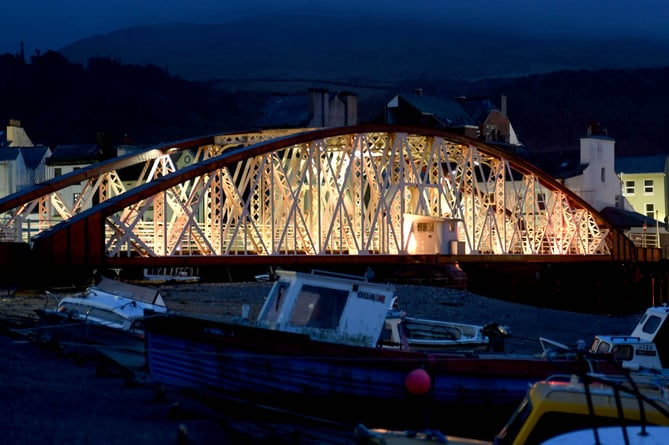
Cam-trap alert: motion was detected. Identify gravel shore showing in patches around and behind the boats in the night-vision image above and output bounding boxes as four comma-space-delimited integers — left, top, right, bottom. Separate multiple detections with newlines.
0, 282, 641, 445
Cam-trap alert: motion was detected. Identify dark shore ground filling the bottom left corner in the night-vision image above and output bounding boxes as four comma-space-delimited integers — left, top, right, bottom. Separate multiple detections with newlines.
0, 335, 366, 445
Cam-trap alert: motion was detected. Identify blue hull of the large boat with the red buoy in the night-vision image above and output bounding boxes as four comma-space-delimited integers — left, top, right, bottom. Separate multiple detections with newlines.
145, 316, 596, 431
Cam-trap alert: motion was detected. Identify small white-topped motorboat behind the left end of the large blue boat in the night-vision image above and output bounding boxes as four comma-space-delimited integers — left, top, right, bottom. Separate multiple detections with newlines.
34, 277, 167, 354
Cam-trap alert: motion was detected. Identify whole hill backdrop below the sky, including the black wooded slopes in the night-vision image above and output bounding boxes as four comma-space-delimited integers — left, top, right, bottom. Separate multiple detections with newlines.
0, 16, 669, 155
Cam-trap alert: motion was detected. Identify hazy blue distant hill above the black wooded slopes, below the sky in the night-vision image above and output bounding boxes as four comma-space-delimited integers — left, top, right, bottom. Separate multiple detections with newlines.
60, 13, 669, 85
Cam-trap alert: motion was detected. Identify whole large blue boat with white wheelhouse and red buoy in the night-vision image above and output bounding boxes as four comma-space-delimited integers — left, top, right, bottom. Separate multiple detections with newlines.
145, 271, 620, 434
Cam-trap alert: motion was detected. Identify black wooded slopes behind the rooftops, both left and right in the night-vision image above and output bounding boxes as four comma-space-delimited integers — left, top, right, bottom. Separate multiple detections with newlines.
0, 51, 669, 155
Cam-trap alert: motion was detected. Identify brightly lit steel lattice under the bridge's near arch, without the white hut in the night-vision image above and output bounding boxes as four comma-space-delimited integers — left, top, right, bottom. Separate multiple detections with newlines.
104, 128, 611, 257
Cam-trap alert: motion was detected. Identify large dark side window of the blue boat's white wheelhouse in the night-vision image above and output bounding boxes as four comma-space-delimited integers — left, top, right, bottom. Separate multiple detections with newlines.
290, 285, 349, 330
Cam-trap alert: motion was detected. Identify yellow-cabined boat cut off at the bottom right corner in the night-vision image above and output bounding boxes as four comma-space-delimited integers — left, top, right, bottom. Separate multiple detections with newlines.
353, 373, 669, 445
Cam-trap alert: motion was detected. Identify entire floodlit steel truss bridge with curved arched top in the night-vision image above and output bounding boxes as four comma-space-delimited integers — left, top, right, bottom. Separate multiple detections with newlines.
0, 126, 637, 268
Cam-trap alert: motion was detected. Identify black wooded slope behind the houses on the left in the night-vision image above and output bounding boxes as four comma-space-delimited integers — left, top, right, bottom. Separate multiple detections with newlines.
0, 51, 267, 147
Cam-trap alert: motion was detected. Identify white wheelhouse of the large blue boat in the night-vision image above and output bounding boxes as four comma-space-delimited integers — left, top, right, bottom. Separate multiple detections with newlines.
256, 270, 396, 347
